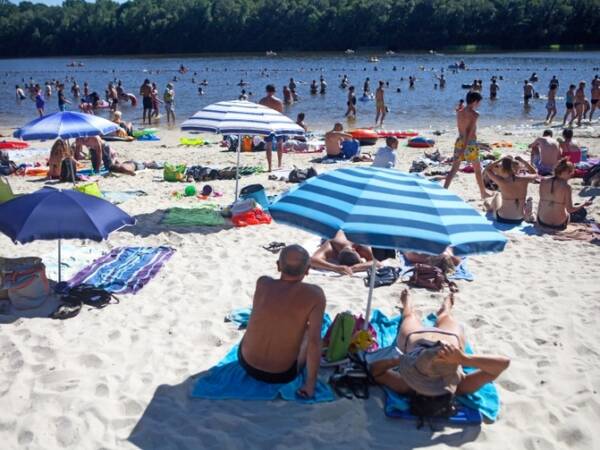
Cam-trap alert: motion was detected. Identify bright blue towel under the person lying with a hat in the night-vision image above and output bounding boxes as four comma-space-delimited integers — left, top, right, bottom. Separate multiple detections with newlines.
371, 310, 500, 423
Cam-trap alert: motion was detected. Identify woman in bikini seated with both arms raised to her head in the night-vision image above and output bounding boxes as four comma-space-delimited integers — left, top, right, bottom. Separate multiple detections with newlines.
483, 156, 537, 224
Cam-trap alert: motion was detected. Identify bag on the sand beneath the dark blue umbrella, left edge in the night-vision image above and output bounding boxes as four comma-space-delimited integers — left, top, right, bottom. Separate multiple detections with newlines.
2, 261, 50, 310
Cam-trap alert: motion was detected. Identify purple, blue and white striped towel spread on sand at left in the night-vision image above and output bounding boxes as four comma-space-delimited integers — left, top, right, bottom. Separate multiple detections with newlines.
69, 247, 175, 294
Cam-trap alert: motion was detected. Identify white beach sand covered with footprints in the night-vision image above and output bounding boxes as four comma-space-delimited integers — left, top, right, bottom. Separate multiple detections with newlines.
0, 122, 600, 450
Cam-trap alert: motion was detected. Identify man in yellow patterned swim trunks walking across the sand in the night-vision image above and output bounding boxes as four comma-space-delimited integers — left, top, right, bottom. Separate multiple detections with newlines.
444, 92, 489, 199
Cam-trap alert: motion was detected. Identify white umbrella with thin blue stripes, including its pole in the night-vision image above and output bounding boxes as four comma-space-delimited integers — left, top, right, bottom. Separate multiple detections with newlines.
181, 100, 304, 200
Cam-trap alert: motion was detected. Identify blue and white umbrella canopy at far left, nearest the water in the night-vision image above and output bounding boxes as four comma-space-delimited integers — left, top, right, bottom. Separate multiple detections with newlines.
14, 111, 119, 140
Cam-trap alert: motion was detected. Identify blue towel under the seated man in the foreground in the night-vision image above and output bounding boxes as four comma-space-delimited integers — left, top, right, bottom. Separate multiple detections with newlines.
190, 308, 335, 404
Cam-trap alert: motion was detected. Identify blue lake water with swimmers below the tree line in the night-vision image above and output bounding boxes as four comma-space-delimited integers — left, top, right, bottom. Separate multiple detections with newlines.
0, 52, 600, 130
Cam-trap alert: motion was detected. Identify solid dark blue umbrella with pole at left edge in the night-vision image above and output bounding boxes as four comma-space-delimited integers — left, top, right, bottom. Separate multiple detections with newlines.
0, 187, 135, 282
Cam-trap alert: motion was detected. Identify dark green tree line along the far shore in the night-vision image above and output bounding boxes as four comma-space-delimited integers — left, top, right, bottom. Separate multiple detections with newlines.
0, 0, 600, 57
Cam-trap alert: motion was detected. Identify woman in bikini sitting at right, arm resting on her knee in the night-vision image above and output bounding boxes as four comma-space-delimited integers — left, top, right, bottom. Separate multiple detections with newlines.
537, 158, 592, 231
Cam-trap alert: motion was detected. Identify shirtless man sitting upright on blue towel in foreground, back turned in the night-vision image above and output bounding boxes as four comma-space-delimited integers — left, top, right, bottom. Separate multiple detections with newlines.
238, 245, 326, 398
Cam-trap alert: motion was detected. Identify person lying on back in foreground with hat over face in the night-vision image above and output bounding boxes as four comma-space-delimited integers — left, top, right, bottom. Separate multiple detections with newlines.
365, 289, 510, 397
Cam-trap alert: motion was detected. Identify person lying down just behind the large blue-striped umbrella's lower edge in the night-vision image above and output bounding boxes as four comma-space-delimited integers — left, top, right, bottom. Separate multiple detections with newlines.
310, 230, 379, 275
